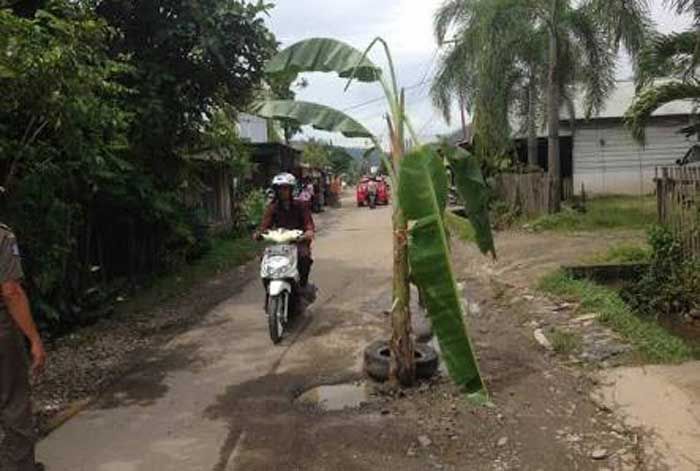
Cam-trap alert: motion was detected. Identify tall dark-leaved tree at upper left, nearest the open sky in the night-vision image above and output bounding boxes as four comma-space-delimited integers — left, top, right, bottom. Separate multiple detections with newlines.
96, 0, 276, 159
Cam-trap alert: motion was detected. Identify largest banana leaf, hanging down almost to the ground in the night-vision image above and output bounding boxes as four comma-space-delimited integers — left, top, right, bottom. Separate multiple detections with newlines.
398, 147, 488, 403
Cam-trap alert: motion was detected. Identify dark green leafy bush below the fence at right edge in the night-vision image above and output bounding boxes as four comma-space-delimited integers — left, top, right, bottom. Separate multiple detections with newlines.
623, 226, 700, 318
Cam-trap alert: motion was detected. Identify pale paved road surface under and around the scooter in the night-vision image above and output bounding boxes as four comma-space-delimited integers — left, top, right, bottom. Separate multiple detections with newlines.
39, 207, 400, 471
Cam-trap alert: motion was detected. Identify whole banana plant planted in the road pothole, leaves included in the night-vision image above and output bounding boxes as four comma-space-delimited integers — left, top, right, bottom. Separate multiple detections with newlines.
256, 38, 495, 401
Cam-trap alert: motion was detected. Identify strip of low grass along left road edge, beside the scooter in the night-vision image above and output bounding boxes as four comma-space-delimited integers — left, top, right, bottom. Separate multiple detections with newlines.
127, 235, 262, 311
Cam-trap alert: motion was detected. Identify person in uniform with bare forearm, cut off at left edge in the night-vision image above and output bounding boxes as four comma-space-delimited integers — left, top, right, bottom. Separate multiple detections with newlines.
0, 224, 46, 471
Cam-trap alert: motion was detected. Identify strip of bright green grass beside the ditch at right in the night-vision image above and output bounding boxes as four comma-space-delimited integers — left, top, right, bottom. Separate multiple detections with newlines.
539, 271, 693, 363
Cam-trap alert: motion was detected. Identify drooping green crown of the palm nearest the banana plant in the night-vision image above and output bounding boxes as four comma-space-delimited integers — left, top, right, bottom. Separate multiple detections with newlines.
431, 0, 542, 169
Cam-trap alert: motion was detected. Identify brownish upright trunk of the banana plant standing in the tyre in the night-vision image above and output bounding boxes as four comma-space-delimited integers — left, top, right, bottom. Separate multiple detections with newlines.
388, 109, 416, 387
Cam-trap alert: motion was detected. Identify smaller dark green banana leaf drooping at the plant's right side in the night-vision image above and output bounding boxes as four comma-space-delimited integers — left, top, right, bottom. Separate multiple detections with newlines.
441, 147, 496, 257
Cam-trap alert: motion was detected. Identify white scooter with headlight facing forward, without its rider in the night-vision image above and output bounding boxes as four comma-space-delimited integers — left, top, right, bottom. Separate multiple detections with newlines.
260, 229, 303, 344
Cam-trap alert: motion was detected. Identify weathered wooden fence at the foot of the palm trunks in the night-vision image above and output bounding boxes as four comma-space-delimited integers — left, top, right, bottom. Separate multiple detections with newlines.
494, 172, 573, 217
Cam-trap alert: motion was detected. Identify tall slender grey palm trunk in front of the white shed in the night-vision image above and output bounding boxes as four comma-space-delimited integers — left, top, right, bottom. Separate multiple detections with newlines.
547, 12, 561, 212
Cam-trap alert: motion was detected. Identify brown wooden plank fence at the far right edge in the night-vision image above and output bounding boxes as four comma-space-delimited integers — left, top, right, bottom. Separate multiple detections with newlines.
655, 167, 700, 256
